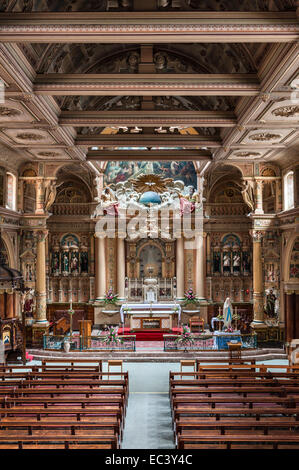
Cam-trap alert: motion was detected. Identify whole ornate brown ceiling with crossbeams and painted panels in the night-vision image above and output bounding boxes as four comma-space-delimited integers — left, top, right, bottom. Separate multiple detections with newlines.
0, 0, 299, 173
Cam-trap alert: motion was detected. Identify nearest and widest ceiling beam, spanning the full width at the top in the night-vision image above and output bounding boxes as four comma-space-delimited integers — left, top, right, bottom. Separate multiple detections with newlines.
0, 11, 299, 44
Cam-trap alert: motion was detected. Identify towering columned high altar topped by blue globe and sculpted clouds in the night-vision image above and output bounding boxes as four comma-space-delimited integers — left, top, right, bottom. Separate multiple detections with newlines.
94, 173, 205, 331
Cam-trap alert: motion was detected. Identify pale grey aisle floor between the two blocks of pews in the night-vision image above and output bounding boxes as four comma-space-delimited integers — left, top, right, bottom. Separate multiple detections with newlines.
104, 362, 179, 449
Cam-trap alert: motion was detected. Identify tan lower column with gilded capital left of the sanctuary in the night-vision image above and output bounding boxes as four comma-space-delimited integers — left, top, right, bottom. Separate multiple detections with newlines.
35, 231, 48, 323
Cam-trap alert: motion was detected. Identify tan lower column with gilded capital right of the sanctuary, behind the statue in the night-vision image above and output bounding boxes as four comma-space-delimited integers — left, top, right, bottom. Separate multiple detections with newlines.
252, 230, 264, 323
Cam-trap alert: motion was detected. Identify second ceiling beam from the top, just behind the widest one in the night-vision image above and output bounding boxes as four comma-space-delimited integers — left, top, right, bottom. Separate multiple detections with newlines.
33, 73, 260, 96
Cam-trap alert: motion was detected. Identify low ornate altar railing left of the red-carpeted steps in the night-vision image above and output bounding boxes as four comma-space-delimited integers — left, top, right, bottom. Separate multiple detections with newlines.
43, 335, 136, 351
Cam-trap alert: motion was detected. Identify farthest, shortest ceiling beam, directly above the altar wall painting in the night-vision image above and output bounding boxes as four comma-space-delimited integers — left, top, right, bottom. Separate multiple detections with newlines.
86, 150, 212, 161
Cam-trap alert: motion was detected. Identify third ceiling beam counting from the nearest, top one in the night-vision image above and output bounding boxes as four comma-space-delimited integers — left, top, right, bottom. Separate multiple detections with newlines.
59, 110, 237, 127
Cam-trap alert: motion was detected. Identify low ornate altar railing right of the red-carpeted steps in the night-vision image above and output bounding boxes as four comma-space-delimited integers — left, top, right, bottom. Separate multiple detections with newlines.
164, 333, 257, 351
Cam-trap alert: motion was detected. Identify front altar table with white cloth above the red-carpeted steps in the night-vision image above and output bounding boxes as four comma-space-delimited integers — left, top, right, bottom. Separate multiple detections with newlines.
120, 302, 181, 331
